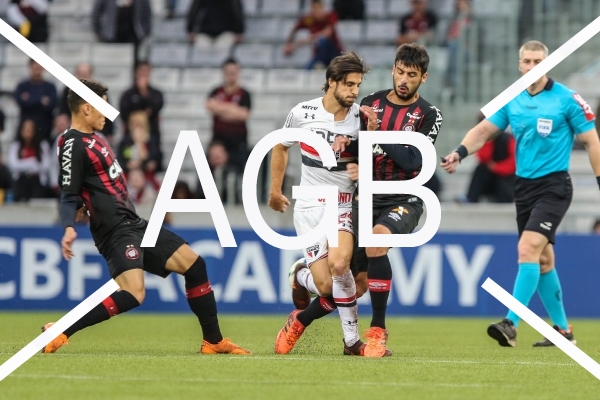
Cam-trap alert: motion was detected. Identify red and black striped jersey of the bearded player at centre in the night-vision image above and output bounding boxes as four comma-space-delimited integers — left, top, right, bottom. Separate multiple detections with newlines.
359, 89, 442, 207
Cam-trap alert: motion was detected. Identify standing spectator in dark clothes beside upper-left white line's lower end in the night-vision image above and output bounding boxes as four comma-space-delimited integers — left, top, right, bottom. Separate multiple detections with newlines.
119, 61, 164, 171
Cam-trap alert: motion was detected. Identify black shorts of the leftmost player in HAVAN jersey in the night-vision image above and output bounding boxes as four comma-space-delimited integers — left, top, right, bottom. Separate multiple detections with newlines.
97, 219, 187, 279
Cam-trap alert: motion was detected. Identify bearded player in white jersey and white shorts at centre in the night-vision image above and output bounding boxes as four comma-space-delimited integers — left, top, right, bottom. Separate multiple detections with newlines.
269, 52, 382, 355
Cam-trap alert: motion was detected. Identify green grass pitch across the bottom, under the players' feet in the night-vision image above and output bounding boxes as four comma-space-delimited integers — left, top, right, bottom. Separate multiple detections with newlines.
0, 312, 600, 400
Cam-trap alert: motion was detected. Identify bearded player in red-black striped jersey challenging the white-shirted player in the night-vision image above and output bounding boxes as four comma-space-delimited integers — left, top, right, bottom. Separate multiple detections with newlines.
348, 44, 442, 357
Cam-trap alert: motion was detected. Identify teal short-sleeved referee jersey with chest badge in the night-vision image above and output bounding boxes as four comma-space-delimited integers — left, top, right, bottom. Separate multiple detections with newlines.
488, 79, 595, 179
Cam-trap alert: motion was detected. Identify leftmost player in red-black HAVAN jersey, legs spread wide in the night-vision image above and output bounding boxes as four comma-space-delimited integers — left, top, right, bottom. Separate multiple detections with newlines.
43, 80, 250, 354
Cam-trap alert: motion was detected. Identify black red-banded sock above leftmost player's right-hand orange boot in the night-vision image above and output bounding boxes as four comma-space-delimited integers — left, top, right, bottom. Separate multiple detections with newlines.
183, 257, 223, 344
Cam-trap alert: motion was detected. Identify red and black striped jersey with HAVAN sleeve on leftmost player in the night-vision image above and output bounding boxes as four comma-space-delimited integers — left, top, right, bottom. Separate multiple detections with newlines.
57, 129, 139, 244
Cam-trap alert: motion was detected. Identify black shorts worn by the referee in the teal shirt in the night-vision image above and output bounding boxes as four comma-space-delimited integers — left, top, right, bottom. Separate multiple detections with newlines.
515, 172, 573, 244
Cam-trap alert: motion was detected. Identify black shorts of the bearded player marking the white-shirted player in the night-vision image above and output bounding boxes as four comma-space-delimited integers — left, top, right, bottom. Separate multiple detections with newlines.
350, 203, 423, 276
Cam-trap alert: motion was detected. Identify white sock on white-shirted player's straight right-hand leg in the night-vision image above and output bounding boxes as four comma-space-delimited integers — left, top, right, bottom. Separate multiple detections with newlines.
332, 271, 360, 347
